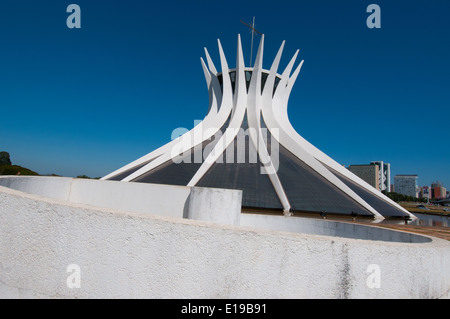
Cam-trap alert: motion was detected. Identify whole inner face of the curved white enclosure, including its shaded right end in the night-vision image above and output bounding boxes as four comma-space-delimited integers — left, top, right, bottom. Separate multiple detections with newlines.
0, 176, 431, 243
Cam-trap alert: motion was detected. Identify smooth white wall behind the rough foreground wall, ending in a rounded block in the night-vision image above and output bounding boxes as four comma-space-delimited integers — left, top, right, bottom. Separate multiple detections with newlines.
0, 176, 242, 221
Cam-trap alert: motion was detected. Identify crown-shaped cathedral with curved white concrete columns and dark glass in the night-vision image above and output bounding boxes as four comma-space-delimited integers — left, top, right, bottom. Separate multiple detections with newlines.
102, 35, 412, 219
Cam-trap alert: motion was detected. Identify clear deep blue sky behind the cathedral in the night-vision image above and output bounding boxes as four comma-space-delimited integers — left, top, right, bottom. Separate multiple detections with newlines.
0, 0, 450, 188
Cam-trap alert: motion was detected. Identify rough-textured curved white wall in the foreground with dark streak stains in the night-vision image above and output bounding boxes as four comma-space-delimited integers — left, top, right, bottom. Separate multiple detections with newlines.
0, 176, 450, 298
